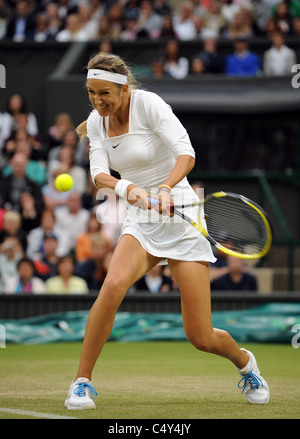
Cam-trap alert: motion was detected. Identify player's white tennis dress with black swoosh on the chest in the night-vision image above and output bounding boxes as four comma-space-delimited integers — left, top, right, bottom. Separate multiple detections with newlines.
87, 90, 216, 262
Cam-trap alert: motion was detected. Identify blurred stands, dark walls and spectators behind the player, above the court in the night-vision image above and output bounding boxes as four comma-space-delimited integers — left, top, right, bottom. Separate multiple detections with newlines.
0, 0, 300, 330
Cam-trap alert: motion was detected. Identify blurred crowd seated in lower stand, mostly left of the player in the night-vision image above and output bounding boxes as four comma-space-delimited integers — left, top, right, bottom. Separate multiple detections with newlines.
0, 94, 255, 294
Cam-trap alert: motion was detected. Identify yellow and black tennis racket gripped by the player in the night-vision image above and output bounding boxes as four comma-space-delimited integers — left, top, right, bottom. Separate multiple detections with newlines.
149, 191, 272, 259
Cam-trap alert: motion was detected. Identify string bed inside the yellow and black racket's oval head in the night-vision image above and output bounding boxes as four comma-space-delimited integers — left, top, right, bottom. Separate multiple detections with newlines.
204, 197, 268, 253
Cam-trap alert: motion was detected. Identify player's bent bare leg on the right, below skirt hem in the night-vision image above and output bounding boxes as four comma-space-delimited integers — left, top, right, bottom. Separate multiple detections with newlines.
169, 260, 249, 369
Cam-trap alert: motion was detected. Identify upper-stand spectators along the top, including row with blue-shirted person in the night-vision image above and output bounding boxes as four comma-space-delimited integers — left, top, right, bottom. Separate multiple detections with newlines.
0, 0, 300, 77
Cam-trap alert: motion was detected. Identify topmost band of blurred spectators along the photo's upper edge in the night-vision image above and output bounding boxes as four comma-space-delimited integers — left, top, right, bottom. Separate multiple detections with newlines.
0, 0, 300, 42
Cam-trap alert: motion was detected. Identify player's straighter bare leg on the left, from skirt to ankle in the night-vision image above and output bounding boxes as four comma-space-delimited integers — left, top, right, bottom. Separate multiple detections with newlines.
76, 235, 160, 379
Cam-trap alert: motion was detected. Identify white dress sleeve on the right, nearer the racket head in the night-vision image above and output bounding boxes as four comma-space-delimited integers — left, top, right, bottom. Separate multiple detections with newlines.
144, 93, 195, 159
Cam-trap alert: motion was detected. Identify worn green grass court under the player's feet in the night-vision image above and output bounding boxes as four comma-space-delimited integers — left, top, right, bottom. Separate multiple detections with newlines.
0, 341, 300, 419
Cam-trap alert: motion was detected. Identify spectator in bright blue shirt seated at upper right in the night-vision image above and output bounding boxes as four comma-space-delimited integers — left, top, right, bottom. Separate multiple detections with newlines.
225, 35, 260, 76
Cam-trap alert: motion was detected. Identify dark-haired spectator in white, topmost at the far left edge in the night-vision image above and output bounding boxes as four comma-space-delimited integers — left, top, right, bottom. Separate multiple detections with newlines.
1, 93, 39, 147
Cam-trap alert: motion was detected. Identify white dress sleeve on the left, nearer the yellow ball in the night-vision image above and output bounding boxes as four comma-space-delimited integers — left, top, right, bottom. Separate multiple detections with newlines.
87, 113, 110, 183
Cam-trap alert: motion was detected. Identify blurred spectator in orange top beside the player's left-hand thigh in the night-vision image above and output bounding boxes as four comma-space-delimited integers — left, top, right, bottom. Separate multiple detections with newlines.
75, 213, 111, 262
